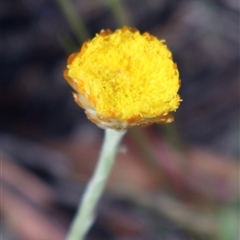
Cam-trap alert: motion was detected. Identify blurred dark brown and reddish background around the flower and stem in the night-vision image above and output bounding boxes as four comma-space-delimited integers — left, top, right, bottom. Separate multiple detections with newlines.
0, 0, 240, 240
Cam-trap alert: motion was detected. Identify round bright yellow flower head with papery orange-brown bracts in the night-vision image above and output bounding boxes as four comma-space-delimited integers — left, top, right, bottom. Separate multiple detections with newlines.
64, 27, 181, 129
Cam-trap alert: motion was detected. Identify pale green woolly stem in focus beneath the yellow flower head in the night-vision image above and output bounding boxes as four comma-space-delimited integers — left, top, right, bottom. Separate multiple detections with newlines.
66, 129, 125, 240
